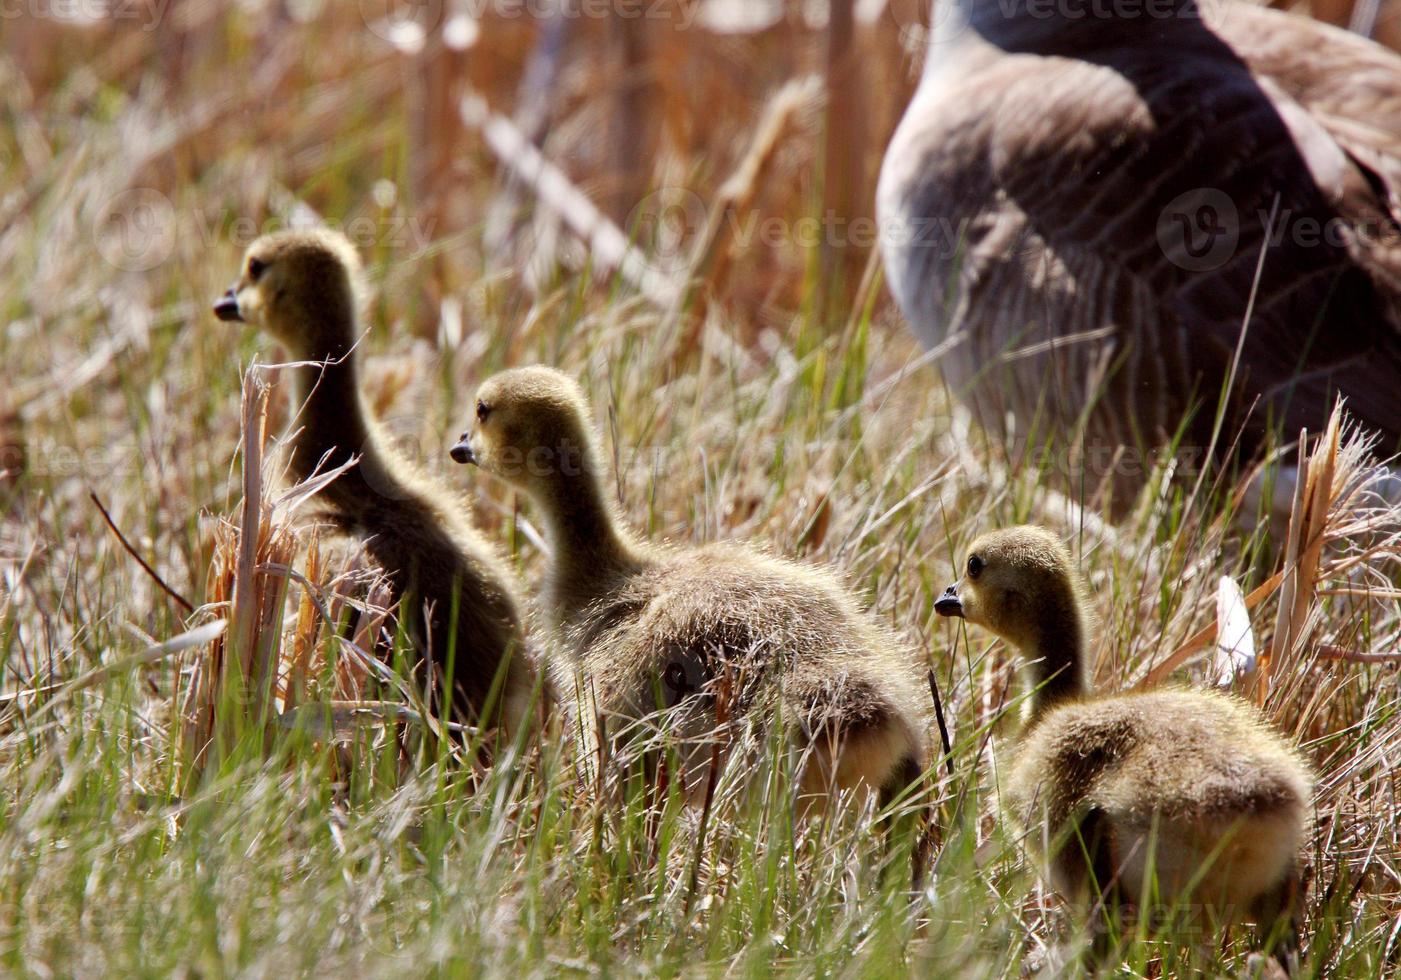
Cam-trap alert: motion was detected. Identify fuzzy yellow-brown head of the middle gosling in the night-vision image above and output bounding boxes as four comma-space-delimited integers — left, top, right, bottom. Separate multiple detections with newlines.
453, 367, 597, 496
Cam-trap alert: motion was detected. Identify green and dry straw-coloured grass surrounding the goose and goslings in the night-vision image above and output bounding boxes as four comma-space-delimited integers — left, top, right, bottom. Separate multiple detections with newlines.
0, 3, 1401, 977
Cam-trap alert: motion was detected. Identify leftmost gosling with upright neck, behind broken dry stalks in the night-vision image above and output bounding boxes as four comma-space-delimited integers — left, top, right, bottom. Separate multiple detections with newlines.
214, 230, 534, 721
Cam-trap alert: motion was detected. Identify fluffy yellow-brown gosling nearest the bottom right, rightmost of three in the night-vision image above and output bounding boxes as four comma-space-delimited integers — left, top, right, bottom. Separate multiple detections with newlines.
934, 526, 1313, 965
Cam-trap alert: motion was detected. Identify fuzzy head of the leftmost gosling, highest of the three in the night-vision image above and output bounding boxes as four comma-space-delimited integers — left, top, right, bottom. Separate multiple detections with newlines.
214, 228, 363, 360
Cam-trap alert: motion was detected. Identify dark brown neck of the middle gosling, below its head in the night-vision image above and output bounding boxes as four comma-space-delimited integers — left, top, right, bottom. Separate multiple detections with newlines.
534, 447, 640, 606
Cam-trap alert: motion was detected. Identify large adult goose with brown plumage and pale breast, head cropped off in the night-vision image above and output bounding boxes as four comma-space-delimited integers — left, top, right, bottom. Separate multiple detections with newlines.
877, 0, 1401, 501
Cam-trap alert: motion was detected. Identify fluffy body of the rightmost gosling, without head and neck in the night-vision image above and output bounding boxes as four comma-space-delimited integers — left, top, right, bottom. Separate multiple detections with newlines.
1006, 689, 1310, 912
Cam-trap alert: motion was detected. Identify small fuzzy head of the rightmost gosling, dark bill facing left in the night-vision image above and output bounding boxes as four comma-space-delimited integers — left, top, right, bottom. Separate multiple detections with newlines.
934, 526, 1079, 648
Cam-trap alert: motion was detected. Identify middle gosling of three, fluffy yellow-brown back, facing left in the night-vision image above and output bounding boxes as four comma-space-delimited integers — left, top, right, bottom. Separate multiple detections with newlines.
453, 367, 927, 801
